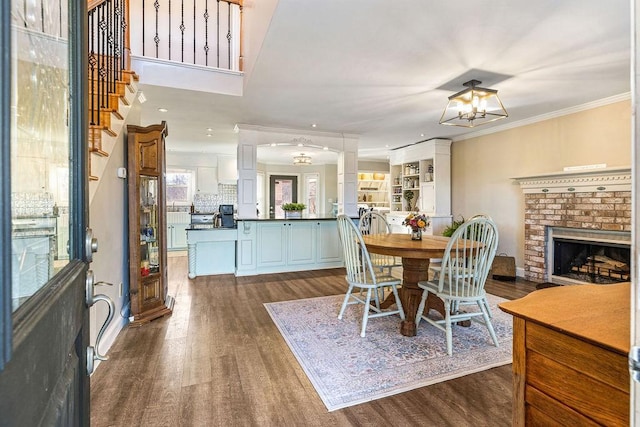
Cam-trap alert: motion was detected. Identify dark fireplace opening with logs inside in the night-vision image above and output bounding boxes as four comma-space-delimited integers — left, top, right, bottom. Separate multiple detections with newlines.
552, 238, 631, 284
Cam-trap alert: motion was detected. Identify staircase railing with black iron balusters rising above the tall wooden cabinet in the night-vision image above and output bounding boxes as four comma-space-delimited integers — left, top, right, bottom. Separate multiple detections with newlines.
88, 0, 129, 136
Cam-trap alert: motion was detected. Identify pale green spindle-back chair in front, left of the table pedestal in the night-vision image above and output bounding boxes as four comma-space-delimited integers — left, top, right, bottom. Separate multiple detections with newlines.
336, 214, 405, 337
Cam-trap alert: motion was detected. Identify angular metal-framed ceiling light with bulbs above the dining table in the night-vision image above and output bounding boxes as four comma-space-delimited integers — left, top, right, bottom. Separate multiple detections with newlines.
440, 80, 509, 128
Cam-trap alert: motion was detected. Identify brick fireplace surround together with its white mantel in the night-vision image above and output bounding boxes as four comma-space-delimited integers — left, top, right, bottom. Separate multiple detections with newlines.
516, 168, 631, 282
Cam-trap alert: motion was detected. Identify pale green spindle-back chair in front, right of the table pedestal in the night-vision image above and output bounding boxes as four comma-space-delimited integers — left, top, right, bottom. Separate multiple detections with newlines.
416, 217, 498, 355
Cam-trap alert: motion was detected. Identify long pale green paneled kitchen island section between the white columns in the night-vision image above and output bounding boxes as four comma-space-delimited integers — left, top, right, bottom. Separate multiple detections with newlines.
236, 217, 344, 276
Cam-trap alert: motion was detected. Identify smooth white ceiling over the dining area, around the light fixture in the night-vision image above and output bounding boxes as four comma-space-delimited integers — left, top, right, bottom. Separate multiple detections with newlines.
141, 0, 631, 163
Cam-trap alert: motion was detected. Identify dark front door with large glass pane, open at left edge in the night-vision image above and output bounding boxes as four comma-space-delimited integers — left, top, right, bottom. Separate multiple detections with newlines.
0, 0, 92, 426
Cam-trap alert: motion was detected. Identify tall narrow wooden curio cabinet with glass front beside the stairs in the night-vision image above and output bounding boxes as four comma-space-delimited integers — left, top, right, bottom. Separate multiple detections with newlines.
127, 122, 173, 326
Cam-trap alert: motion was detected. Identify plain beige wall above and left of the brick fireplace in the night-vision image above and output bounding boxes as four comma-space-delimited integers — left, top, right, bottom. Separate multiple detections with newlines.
451, 101, 631, 274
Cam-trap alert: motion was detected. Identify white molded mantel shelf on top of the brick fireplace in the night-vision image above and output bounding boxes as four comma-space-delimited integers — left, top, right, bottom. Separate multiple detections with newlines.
512, 167, 631, 194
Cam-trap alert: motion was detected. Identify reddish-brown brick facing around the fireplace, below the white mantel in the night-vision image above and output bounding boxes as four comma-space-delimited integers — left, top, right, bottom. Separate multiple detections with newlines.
524, 191, 631, 282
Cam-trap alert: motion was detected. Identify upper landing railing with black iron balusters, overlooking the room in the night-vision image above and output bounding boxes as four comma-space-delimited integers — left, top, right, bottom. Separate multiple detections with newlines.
131, 0, 243, 71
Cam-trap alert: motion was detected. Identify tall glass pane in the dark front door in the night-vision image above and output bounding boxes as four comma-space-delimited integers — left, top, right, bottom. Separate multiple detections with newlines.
11, 2, 70, 311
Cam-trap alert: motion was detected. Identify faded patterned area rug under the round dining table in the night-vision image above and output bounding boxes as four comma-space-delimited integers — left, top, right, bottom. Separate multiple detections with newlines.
264, 295, 512, 411
